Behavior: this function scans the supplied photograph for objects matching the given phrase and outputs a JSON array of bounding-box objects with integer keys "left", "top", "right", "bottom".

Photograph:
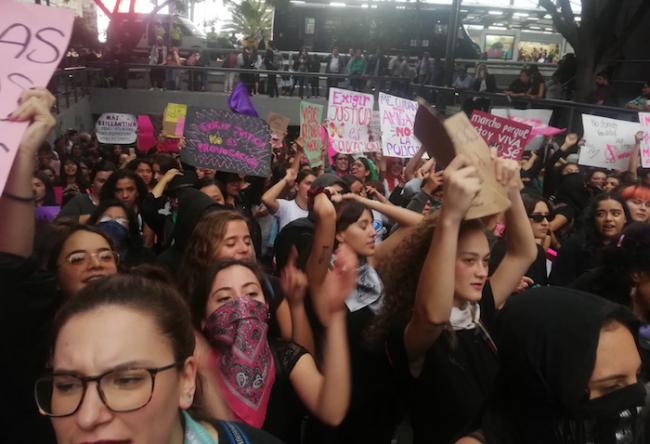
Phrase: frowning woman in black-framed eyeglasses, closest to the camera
[{"left": 34, "top": 275, "right": 279, "bottom": 444}]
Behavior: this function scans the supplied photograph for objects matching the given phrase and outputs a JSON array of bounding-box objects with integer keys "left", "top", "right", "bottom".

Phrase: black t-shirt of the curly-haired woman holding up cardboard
[{"left": 387, "top": 284, "right": 497, "bottom": 444}]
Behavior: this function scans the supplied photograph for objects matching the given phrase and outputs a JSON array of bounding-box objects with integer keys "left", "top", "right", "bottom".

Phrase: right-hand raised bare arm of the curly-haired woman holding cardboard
[{"left": 490, "top": 159, "right": 537, "bottom": 308}]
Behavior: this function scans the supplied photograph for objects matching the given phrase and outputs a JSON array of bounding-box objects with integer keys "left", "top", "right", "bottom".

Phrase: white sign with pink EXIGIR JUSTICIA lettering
[{"left": 327, "top": 88, "right": 380, "bottom": 154}]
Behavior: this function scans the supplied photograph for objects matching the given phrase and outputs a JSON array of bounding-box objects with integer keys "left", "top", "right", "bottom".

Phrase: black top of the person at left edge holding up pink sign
[{"left": 0, "top": 253, "right": 61, "bottom": 444}]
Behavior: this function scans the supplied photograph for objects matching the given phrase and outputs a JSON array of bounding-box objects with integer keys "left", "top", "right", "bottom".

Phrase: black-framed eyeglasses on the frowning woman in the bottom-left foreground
[{"left": 34, "top": 362, "right": 178, "bottom": 418}]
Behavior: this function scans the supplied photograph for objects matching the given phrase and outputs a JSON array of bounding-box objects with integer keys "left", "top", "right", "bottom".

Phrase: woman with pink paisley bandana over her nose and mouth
[{"left": 191, "top": 248, "right": 356, "bottom": 444}]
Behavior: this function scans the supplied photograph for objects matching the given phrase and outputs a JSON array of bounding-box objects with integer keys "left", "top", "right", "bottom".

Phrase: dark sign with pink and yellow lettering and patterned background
[{"left": 181, "top": 106, "right": 271, "bottom": 177}]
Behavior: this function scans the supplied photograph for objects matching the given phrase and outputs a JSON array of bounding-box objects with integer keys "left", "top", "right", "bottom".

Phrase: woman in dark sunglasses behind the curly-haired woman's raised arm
[{"left": 490, "top": 193, "right": 551, "bottom": 291}]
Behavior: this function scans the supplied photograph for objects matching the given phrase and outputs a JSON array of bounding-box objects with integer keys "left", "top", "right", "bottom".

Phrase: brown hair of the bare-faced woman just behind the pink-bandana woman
[{"left": 179, "top": 210, "right": 247, "bottom": 300}]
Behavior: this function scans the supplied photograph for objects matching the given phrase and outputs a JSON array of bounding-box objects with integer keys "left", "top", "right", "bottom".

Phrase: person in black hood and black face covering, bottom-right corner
[{"left": 458, "top": 287, "right": 648, "bottom": 444}]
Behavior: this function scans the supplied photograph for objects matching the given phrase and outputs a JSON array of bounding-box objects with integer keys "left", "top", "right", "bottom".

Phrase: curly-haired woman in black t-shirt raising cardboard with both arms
[{"left": 373, "top": 155, "right": 537, "bottom": 444}]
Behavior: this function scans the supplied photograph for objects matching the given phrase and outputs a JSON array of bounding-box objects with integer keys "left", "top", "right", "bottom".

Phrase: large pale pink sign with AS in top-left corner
[{"left": 0, "top": 0, "right": 74, "bottom": 193}]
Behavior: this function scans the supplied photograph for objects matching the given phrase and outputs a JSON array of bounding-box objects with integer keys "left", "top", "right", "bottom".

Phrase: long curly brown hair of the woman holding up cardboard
[{"left": 366, "top": 215, "right": 485, "bottom": 346}]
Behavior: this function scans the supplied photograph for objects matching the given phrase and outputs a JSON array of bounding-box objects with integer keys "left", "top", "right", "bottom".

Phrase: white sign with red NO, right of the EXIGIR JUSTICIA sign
[{"left": 379, "top": 92, "right": 420, "bottom": 157}]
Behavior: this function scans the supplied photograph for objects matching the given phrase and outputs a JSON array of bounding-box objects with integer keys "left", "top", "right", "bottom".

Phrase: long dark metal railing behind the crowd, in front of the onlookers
[{"left": 49, "top": 63, "right": 638, "bottom": 132}]
